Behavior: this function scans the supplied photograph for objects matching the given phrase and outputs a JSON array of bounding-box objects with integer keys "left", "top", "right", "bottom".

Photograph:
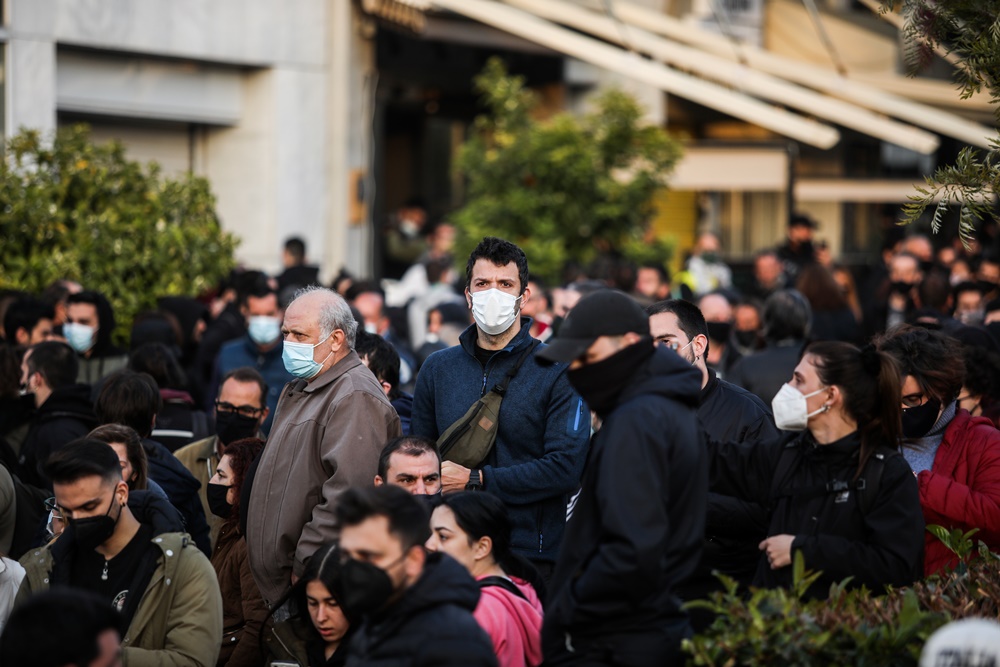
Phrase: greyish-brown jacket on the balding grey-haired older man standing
[{"left": 246, "top": 352, "right": 401, "bottom": 606}]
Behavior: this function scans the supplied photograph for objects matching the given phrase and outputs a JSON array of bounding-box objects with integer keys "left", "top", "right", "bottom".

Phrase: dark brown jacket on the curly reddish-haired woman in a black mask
[{"left": 212, "top": 523, "right": 268, "bottom": 667}]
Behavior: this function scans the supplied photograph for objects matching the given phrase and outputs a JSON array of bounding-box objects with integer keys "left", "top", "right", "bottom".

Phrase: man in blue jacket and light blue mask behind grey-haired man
[{"left": 209, "top": 287, "right": 295, "bottom": 435}]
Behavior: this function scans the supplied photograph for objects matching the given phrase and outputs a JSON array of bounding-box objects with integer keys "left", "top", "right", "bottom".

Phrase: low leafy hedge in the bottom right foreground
[{"left": 684, "top": 526, "right": 1000, "bottom": 667}]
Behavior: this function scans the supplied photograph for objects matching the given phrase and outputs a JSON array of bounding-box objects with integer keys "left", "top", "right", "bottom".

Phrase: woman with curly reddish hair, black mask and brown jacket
[{"left": 206, "top": 438, "right": 267, "bottom": 667}]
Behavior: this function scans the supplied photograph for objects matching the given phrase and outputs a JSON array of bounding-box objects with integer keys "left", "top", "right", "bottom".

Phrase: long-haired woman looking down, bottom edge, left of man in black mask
[{"left": 266, "top": 543, "right": 356, "bottom": 667}]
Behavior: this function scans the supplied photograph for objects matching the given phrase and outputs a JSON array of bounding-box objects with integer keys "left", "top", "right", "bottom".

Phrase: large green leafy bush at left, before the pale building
[{"left": 0, "top": 125, "right": 237, "bottom": 343}]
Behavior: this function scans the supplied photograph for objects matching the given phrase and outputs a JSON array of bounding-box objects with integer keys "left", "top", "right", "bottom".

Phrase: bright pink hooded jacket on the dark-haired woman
[{"left": 472, "top": 577, "right": 542, "bottom": 667}]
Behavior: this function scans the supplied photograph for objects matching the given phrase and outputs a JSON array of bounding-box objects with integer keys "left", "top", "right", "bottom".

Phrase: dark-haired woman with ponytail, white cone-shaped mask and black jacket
[{"left": 709, "top": 341, "right": 924, "bottom": 598}]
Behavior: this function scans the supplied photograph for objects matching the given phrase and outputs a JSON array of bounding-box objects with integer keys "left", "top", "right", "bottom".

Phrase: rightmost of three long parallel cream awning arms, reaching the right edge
[{"left": 615, "top": 0, "right": 997, "bottom": 148}]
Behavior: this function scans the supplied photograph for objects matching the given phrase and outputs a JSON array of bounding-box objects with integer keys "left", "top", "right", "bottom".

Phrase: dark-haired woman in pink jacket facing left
[{"left": 426, "top": 491, "right": 544, "bottom": 667}]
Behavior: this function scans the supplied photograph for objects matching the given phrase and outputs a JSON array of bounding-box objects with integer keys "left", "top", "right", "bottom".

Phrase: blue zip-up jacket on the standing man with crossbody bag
[{"left": 410, "top": 317, "right": 590, "bottom": 562}]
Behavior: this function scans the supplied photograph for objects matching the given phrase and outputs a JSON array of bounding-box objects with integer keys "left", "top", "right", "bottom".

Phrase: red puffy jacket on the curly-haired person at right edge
[{"left": 917, "top": 410, "right": 1000, "bottom": 575}]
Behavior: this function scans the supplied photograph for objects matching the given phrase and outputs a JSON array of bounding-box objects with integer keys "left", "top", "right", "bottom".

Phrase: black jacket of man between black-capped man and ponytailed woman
[{"left": 678, "top": 369, "right": 781, "bottom": 600}]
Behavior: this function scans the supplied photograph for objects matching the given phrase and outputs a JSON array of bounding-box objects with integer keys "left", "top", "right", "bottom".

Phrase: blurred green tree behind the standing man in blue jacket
[{"left": 453, "top": 58, "right": 680, "bottom": 281}]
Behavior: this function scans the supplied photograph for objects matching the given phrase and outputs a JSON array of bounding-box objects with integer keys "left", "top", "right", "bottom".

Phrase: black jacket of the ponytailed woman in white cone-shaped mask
[{"left": 709, "top": 431, "right": 924, "bottom": 597}]
